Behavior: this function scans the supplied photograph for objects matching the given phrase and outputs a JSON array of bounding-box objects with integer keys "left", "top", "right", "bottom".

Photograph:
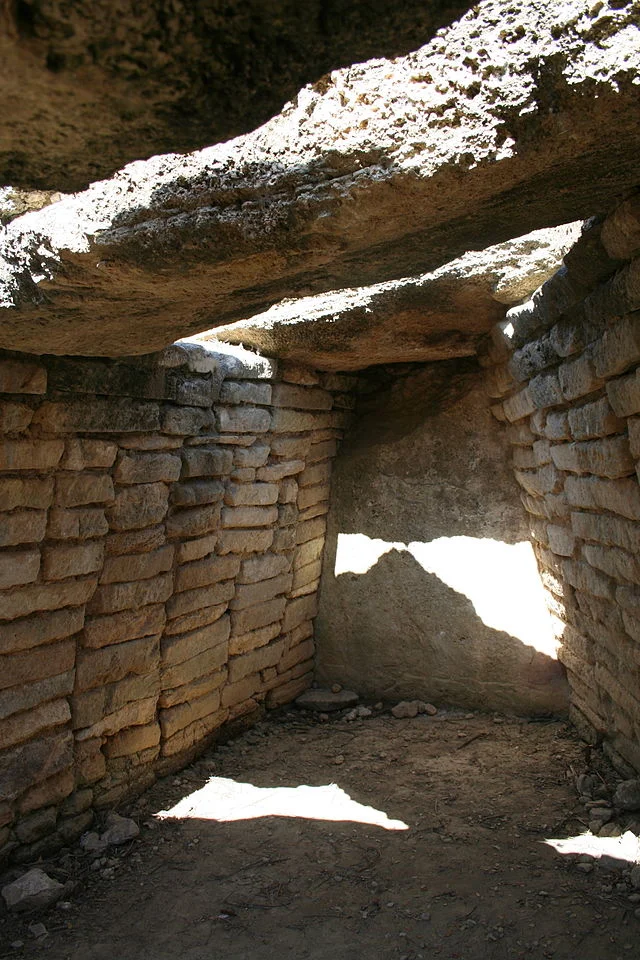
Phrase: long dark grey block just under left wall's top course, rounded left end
[{"left": 34, "top": 396, "right": 160, "bottom": 433}]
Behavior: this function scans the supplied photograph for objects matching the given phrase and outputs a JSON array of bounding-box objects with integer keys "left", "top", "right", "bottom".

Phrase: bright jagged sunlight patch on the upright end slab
[{"left": 335, "top": 533, "right": 559, "bottom": 657}]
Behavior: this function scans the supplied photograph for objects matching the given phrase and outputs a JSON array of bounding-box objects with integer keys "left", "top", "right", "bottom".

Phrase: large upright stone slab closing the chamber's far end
[{"left": 316, "top": 362, "right": 567, "bottom": 714}]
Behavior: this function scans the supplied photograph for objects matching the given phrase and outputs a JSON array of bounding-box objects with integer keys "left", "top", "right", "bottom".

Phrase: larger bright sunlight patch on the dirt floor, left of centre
[{"left": 156, "top": 777, "right": 409, "bottom": 830}]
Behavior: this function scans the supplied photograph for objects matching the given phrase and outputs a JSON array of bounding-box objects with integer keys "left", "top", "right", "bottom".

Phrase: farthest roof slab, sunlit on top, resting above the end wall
[{"left": 212, "top": 222, "right": 580, "bottom": 370}]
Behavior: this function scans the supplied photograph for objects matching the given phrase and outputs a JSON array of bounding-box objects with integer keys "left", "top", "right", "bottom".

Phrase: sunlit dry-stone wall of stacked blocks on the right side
[{"left": 482, "top": 194, "right": 640, "bottom": 773}]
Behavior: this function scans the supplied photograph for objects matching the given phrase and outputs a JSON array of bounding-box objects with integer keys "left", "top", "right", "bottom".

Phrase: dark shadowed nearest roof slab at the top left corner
[{"left": 0, "top": 0, "right": 468, "bottom": 190}]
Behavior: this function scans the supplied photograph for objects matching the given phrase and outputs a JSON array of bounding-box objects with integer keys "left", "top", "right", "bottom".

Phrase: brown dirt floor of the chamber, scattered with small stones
[{"left": 0, "top": 711, "right": 640, "bottom": 960}]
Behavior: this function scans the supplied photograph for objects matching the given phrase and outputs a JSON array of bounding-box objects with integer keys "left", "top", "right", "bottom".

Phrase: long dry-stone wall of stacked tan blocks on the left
[{"left": 0, "top": 343, "right": 352, "bottom": 861}]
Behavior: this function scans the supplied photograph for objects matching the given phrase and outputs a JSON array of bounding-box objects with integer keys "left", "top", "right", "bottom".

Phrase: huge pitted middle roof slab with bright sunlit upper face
[{"left": 0, "top": 0, "right": 640, "bottom": 355}]
